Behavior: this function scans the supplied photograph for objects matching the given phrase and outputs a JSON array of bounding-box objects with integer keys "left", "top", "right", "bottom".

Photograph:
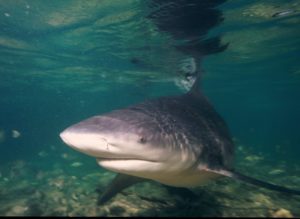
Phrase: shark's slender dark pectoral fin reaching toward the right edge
[{"left": 209, "top": 170, "right": 300, "bottom": 195}]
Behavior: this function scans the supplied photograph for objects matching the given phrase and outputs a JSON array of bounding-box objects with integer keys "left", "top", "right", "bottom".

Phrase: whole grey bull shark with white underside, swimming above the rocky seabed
[{"left": 60, "top": 70, "right": 300, "bottom": 203}]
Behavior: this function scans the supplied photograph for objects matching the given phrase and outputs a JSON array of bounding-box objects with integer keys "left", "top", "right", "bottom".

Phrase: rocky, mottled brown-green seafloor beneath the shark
[{"left": 0, "top": 142, "right": 300, "bottom": 217}]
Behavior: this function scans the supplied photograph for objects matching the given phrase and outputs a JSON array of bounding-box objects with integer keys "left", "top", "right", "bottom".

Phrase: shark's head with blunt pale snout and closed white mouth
[{"left": 60, "top": 109, "right": 195, "bottom": 181}]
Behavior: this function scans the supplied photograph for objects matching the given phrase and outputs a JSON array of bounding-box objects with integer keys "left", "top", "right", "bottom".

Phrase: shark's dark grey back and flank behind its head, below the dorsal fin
[{"left": 108, "top": 93, "right": 234, "bottom": 169}]
